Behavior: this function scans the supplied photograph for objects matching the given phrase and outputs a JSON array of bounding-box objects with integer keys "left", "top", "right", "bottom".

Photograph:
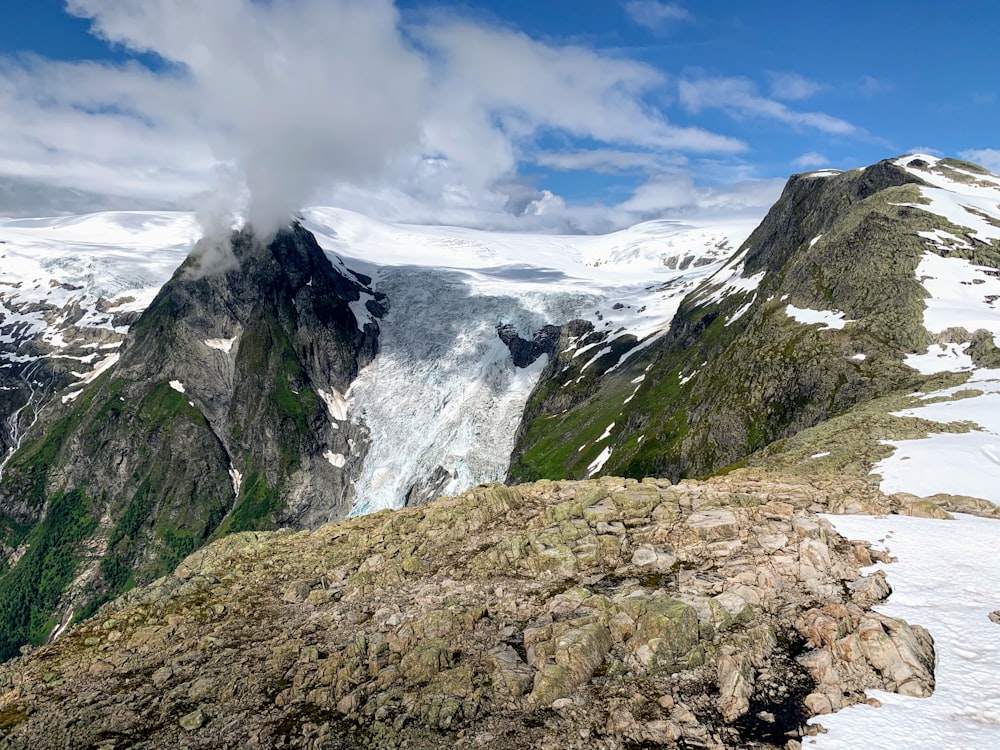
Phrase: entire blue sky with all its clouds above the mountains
[{"left": 0, "top": 0, "right": 1000, "bottom": 231}]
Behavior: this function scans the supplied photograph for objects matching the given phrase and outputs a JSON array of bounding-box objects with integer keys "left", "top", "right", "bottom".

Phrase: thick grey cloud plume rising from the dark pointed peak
[{"left": 68, "top": 0, "right": 426, "bottom": 236}]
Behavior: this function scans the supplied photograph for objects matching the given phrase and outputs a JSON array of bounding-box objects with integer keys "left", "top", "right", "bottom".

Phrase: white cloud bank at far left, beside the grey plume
[{"left": 0, "top": 58, "right": 215, "bottom": 198}]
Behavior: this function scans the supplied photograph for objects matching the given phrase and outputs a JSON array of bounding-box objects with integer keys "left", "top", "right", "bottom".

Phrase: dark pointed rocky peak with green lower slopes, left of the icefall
[{"left": 0, "top": 226, "right": 379, "bottom": 657}]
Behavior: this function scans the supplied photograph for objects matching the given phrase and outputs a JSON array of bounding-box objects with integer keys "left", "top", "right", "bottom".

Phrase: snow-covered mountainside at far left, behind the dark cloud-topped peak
[{"left": 0, "top": 212, "right": 200, "bottom": 464}]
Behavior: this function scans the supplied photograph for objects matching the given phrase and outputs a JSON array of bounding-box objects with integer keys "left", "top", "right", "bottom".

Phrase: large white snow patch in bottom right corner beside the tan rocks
[{"left": 805, "top": 516, "right": 1000, "bottom": 750}]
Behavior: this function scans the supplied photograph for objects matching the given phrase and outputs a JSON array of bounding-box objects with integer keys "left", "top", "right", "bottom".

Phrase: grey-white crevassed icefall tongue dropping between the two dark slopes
[{"left": 347, "top": 267, "right": 598, "bottom": 514}]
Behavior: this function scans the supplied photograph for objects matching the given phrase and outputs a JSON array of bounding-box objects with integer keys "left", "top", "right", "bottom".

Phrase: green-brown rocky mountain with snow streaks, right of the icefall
[{"left": 511, "top": 157, "right": 1000, "bottom": 488}]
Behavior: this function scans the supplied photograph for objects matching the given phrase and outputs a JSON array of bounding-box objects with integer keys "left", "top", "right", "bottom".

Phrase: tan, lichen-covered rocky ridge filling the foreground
[{"left": 0, "top": 471, "right": 944, "bottom": 750}]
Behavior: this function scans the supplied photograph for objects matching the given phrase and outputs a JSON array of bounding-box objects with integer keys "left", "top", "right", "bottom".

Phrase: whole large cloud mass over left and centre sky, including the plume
[{"left": 0, "top": 0, "right": 764, "bottom": 231}]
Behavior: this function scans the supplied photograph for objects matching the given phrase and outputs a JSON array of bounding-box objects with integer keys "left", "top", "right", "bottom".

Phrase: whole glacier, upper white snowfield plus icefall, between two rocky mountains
[{"left": 304, "top": 208, "right": 753, "bottom": 515}]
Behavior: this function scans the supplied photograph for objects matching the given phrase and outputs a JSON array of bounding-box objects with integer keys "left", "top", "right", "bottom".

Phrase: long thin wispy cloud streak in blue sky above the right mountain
[{"left": 678, "top": 76, "right": 864, "bottom": 135}]
